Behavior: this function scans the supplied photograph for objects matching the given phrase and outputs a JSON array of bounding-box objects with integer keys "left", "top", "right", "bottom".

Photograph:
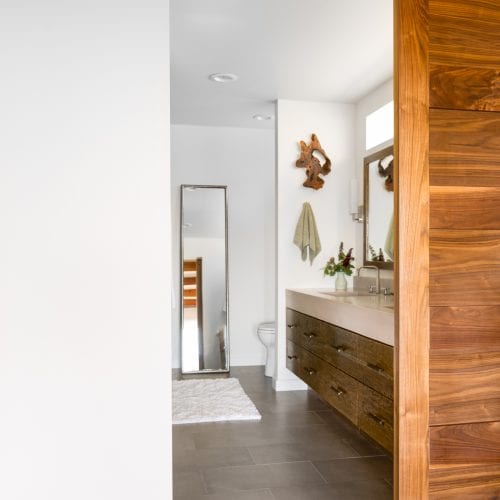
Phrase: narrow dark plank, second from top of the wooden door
[{"left": 430, "top": 64, "right": 500, "bottom": 111}]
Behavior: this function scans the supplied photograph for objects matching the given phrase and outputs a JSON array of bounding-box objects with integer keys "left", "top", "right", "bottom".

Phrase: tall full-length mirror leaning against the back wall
[{"left": 180, "top": 185, "right": 229, "bottom": 374}]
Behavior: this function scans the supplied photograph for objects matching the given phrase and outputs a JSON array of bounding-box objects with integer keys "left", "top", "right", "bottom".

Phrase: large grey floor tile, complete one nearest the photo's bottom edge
[{"left": 203, "top": 462, "right": 325, "bottom": 493}]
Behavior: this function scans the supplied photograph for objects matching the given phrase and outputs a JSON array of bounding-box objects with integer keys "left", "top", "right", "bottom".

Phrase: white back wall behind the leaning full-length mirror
[{"left": 172, "top": 125, "right": 275, "bottom": 367}]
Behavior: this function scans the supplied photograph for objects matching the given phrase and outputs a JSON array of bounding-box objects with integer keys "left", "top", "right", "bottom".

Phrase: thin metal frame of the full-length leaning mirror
[{"left": 179, "top": 184, "right": 230, "bottom": 375}]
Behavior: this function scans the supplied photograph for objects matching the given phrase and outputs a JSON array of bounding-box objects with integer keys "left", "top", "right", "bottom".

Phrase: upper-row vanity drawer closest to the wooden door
[{"left": 357, "top": 335, "right": 394, "bottom": 399}]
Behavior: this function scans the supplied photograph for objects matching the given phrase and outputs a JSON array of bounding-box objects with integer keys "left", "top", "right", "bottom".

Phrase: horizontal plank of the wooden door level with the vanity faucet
[{"left": 429, "top": 229, "right": 500, "bottom": 306}]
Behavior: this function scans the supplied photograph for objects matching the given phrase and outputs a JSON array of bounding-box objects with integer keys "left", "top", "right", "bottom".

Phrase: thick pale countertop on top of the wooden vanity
[{"left": 286, "top": 288, "right": 394, "bottom": 346}]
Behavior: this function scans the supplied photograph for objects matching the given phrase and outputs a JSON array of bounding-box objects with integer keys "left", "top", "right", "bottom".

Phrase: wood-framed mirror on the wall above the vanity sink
[{"left": 364, "top": 146, "right": 394, "bottom": 269}]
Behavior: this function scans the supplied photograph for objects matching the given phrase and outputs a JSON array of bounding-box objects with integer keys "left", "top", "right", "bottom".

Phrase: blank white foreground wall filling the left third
[{"left": 0, "top": 4, "right": 171, "bottom": 500}]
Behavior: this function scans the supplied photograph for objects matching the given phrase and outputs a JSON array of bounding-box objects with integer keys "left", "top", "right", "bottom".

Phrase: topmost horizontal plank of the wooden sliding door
[{"left": 429, "top": 0, "right": 500, "bottom": 69}]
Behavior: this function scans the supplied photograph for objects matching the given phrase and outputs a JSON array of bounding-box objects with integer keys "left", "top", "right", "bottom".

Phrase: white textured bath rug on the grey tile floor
[{"left": 172, "top": 378, "right": 261, "bottom": 424}]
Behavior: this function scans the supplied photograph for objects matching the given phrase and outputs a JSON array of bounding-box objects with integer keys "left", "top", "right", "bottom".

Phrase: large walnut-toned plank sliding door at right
[{"left": 395, "top": 0, "right": 500, "bottom": 500}]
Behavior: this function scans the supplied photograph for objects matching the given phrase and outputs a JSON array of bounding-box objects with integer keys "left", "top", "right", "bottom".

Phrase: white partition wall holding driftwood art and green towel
[{"left": 274, "top": 100, "right": 362, "bottom": 390}]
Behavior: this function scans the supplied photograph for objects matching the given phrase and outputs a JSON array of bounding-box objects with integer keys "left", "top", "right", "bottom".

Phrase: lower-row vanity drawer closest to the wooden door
[{"left": 358, "top": 386, "right": 394, "bottom": 453}]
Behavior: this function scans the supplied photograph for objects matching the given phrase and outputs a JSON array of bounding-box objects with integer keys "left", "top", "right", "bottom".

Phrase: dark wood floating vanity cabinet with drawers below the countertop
[{"left": 286, "top": 309, "right": 394, "bottom": 453}]
